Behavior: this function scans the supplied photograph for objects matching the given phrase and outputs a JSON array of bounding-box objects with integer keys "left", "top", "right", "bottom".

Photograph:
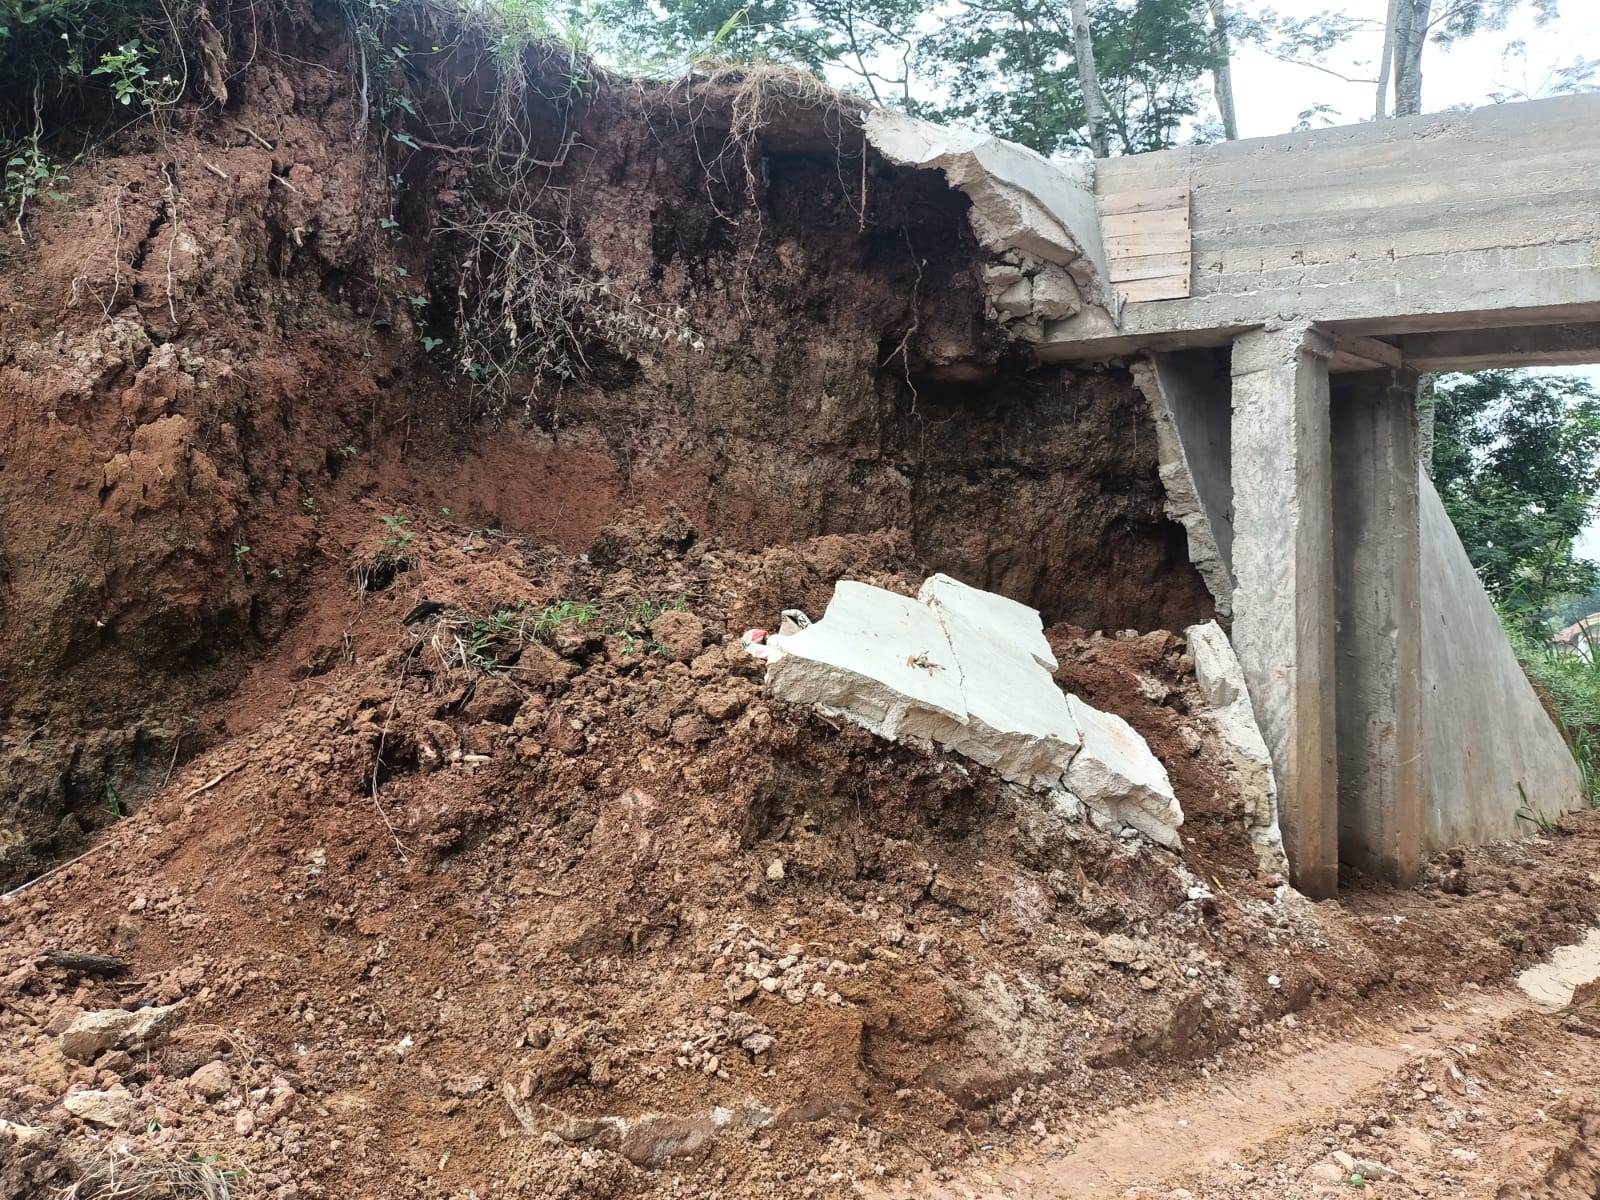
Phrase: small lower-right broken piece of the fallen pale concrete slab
[{"left": 1067, "top": 696, "right": 1184, "bottom": 850}]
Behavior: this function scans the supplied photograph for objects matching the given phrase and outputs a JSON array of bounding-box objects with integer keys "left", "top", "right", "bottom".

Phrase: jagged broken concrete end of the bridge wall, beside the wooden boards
[{"left": 864, "top": 109, "right": 1122, "bottom": 331}]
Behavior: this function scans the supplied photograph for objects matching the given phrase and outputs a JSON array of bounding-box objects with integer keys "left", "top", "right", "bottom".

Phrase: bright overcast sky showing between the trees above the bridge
[{"left": 1234, "top": 0, "right": 1600, "bottom": 560}]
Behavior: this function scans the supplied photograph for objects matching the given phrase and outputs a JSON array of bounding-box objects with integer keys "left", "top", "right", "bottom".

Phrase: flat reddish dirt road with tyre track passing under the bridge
[{"left": 885, "top": 936, "right": 1600, "bottom": 1200}]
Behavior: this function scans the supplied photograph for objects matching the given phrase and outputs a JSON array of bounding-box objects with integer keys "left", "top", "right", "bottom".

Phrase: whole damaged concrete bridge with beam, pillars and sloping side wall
[{"left": 867, "top": 96, "right": 1600, "bottom": 896}]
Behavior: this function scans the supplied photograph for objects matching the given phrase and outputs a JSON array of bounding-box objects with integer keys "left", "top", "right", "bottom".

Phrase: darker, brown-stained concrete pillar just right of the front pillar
[{"left": 1331, "top": 371, "right": 1424, "bottom": 885}]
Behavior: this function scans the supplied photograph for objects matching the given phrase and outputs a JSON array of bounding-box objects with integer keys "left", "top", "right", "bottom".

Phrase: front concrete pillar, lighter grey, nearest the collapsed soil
[{"left": 1232, "top": 326, "right": 1339, "bottom": 898}]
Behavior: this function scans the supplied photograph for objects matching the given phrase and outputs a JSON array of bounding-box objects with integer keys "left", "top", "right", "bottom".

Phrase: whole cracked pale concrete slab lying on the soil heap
[{"left": 766, "top": 574, "right": 1184, "bottom": 850}]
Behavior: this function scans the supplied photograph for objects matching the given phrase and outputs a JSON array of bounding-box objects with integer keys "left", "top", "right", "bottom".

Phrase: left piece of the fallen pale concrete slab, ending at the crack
[{"left": 766, "top": 579, "right": 966, "bottom": 741}]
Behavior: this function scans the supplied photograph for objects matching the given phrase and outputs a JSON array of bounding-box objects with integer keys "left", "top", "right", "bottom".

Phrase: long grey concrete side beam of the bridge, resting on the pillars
[{"left": 1040, "top": 96, "right": 1600, "bottom": 361}]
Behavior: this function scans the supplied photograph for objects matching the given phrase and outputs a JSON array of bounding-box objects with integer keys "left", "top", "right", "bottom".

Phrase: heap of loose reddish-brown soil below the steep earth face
[{"left": 0, "top": 506, "right": 1586, "bottom": 1197}]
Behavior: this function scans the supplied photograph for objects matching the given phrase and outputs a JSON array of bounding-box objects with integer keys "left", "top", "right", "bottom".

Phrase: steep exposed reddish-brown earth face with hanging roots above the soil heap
[{"left": 0, "top": 5, "right": 1210, "bottom": 882}]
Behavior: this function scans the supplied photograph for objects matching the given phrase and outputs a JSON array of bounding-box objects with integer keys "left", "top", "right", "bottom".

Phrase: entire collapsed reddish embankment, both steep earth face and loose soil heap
[{"left": 9, "top": 5, "right": 1589, "bottom": 1200}]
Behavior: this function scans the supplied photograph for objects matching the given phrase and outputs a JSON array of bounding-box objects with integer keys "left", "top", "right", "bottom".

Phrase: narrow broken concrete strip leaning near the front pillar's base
[{"left": 1186, "top": 621, "right": 1288, "bottom": 870}]
